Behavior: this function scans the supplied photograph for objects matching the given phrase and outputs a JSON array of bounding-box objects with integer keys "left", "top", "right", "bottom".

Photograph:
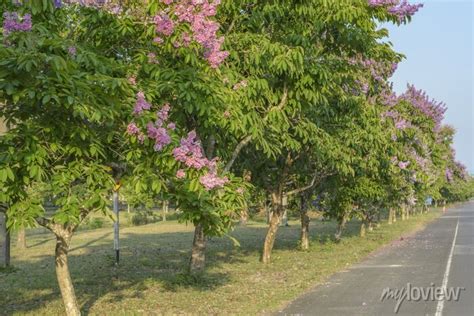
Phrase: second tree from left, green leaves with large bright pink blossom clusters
[{"left": 119, "top": 1, "right": 252, "bottom": 272}]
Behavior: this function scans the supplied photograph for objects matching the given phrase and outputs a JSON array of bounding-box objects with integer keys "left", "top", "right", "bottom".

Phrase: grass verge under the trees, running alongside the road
[{"left": 0, "top": 211, "right": 440, "bottom": 316}]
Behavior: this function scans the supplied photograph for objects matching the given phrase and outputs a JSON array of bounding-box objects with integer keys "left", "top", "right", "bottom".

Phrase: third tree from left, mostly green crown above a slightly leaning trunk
[{"left": 217, "top": 1, "right": 412, "bottom": 262}]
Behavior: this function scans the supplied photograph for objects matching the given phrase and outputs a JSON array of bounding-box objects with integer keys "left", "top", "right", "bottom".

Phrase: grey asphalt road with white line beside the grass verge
[{"left": 277, "top": 201, "right": 474, "bottom": 316}]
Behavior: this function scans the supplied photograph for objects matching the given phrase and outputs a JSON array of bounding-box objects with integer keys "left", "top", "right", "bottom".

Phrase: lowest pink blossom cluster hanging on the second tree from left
[{"left": 173, "top": 131, "right": 229, "bottom": 190}]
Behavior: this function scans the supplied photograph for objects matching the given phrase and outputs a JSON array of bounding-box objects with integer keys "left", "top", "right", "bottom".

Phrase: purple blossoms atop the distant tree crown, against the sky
[{"left": 400, "top": 85, "right": 447, "bottom": 130}]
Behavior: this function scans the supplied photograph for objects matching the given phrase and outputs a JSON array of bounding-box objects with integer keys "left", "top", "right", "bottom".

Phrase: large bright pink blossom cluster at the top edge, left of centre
[{"left": 154, "top": 0, "right": 229, "bottom": 68}]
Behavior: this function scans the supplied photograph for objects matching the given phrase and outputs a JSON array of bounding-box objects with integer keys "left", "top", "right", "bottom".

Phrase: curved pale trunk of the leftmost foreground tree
[{"left": 55, "top": 231, "right": 81, "bottom": 316}]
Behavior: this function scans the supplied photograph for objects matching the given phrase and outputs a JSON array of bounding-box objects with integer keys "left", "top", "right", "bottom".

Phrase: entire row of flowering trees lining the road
[{"left": 0, "top": 0, "right": 472, "bottom": 315}]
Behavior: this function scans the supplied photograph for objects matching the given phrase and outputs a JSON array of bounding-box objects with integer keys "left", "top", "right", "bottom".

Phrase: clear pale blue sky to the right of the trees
[{"left": 384, "top": 0, "right": 474, "bottom": 174}]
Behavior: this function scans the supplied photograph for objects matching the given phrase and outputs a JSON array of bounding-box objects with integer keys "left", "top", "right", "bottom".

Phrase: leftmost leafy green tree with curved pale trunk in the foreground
[{"left": 0, "top": 1, "right": 136, "bottom": 315}]
